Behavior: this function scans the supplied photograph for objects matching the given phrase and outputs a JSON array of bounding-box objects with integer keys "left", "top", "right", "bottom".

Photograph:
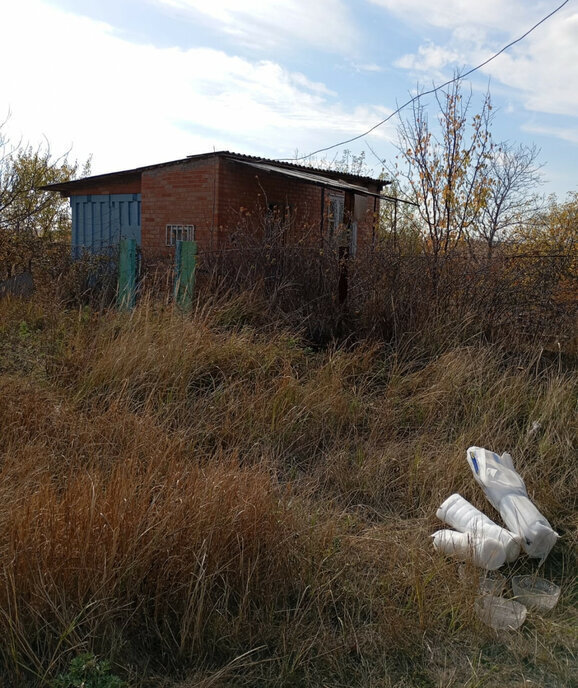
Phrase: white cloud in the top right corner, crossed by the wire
[{"left": 371, "top": 0, "right": 578, "bottom": 128}]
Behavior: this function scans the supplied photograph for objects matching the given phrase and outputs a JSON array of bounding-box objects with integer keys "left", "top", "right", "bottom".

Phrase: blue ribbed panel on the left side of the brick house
[{"left": 70, "top": 194, "right": 141, "bottom": 256}]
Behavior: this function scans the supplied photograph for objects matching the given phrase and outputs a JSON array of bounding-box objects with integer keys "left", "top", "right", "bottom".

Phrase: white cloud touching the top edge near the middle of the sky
[{"left": 149, "top": 0, "right": 359, "bottom": 55}]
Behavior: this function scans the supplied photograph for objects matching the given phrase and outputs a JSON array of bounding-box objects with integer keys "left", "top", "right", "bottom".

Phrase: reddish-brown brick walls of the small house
[{"left": 64, "top": 156, "right": 379, "bottom": 259}]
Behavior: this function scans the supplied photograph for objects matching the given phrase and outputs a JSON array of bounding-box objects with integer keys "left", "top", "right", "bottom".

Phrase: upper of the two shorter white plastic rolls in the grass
[{"left": 436, "top": 493, "right": 522, "bottom": 562}]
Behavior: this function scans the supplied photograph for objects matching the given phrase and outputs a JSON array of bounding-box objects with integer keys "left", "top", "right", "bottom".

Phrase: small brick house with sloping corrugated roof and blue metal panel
[{"left": 43, "top": 151, "right": 390, "bottom": 258}]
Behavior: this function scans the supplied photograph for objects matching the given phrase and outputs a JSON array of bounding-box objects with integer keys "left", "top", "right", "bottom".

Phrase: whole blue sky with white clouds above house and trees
[{"left": 0, "top": 0, "right": 578, "bottom": 199}]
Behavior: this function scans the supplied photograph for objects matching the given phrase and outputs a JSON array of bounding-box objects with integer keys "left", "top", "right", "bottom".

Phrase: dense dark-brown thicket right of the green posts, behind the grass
[{"left": 199, "top": 240, "right": 578, "bottom": 356}]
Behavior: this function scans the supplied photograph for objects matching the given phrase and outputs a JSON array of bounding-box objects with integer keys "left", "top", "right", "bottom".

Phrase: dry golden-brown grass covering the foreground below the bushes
[{"left": 0, "top": 250, "right": 578, "bottom": 688}]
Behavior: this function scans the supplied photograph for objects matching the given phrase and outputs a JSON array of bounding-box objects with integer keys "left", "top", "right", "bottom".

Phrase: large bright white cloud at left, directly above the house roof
[{"left": 0, "top": 0, "right": 390, "bottom": 173}]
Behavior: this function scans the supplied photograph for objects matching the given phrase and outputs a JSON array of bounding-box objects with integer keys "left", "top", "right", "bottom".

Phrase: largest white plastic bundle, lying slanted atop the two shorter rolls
[{"left": 466, "top": 447, "right": 559, "bottom": 561}]
